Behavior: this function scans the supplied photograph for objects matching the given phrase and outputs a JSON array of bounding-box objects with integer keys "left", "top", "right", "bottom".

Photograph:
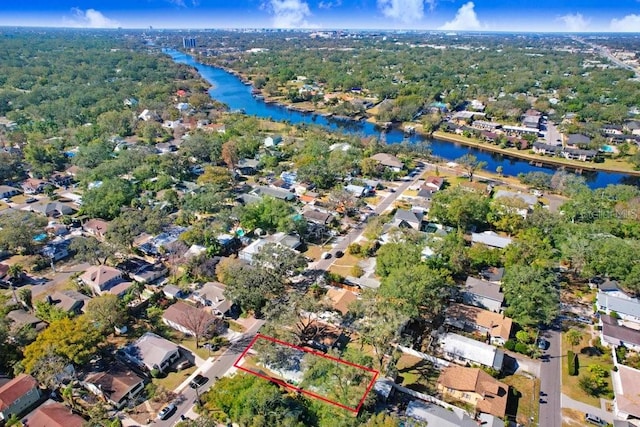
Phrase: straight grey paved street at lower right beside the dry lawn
[{"left": 538, "top": 330, "right": 564, "bottom": 427}]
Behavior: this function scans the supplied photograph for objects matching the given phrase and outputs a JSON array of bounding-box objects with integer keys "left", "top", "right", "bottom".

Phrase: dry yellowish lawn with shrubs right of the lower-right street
[{"left": 561, "top": 330, "right": 613, "bottom": 407}]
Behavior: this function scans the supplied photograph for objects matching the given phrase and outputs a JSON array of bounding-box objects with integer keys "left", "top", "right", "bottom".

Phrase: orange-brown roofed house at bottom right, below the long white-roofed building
[{"left": 437, "top": 366, "right": 509, "bottom": 418}]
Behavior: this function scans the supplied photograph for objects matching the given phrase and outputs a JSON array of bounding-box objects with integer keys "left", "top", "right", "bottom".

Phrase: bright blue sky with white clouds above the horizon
[{"left": 0, "top": 0, "right": 640, "bottom": 32}]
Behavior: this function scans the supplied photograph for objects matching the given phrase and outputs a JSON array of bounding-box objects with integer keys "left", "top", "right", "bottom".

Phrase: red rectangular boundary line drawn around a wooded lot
[{"left": 233, "top": 334, "right": 380, "bottom": 414}]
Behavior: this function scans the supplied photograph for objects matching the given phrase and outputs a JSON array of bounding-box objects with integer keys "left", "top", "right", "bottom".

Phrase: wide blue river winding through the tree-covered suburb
[{"left": 163, "top": 49, "right": 640, "bottom": 188}]
